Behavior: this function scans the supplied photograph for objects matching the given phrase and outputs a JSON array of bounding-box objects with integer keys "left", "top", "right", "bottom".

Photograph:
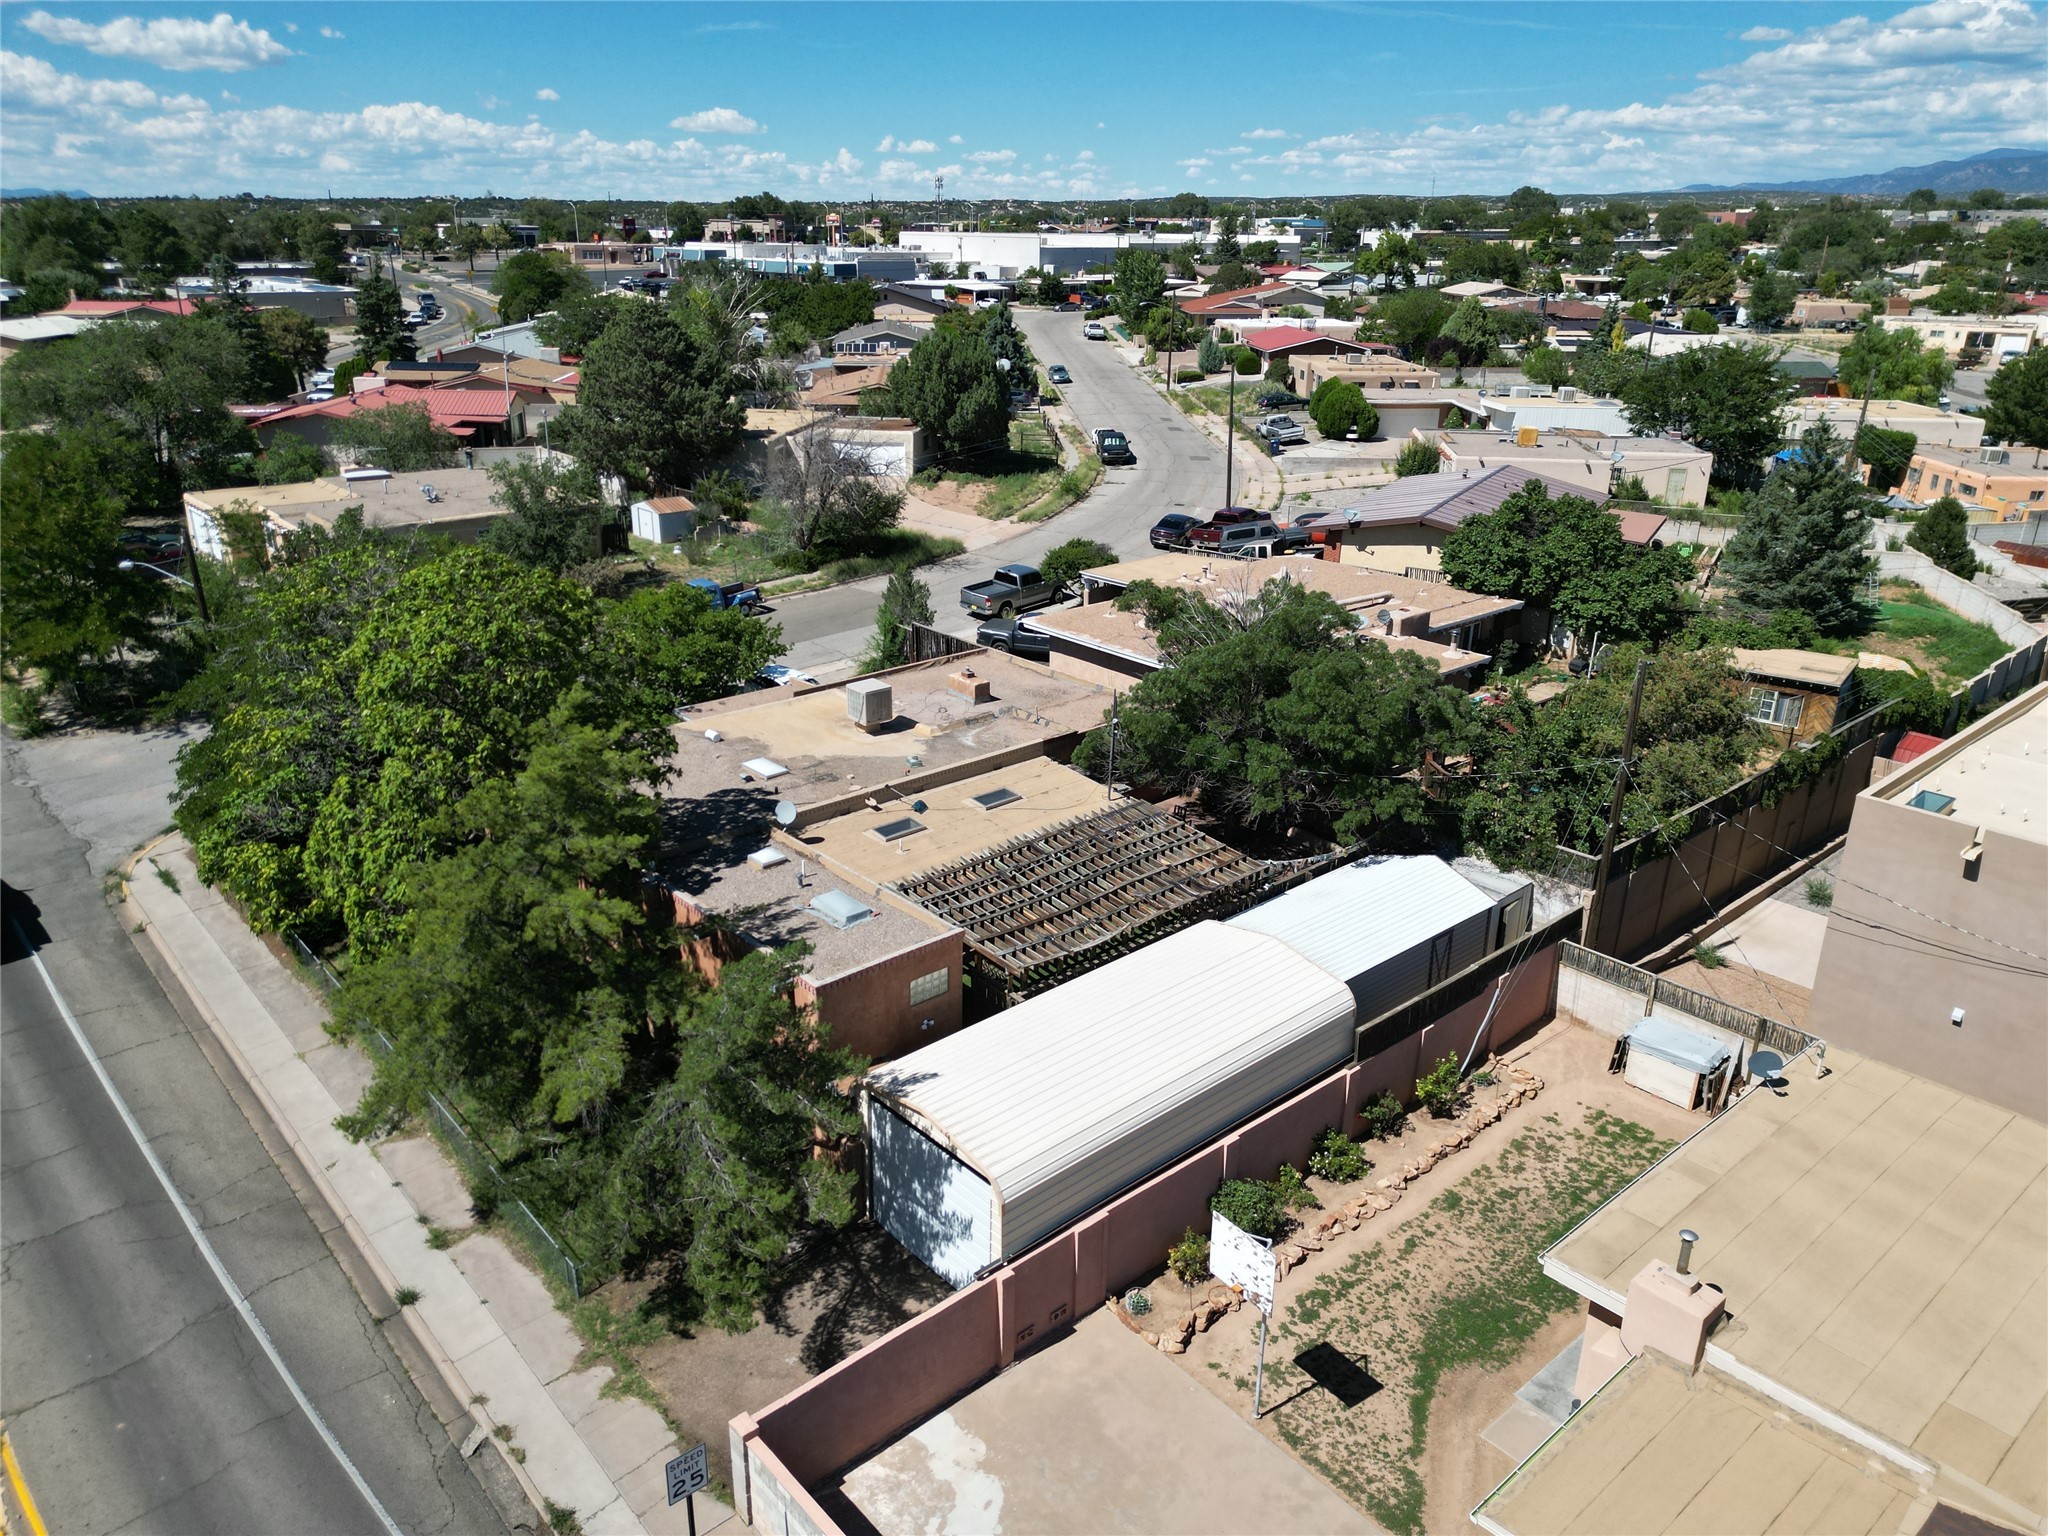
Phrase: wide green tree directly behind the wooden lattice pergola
[{"left": 1075, "top": 580, "right": 1468, "bottom": 842}]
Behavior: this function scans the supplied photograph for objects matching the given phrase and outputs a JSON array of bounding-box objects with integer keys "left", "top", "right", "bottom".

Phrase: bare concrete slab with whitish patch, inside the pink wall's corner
[{"left": 838, "top": 1309, "right": 1374, "bottom": 1536}]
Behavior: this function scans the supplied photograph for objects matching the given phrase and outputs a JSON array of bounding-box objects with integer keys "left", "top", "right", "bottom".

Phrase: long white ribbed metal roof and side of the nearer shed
[{"left": 868, "top": 922, "right": 1354, "bottom": 1253}]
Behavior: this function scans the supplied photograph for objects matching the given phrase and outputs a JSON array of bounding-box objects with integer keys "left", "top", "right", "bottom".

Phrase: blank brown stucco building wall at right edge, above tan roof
[{"left": 1808, "top": 795, "right": 2048, "bottom": 1120}]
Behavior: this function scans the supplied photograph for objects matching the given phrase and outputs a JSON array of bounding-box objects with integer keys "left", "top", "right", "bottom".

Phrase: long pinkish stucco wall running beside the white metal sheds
[{"left": 731, "top": 944, "right": 1559, "bottom": 1536}]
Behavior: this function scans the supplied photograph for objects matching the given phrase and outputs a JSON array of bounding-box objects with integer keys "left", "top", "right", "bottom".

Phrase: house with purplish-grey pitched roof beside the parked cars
[{"left": 1292, "top": 465, "right": 1665, "bottom": 580}]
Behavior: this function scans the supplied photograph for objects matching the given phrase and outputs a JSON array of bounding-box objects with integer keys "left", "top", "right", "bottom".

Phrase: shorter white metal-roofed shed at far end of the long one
[{"left": 1229, "top": 858, "right": 1532, "bottom": 1024}]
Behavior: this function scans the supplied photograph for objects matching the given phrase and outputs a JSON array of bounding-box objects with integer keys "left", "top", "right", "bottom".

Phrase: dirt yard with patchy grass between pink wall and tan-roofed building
[{"left": 1153, "top": 1024, "right": 1702, "bottom": 1532}]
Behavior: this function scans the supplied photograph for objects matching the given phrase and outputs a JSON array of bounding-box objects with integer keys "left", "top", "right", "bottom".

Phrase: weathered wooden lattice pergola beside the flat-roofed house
[{"left": 895, "top": 801, "right": 1272, "bottom": 997}]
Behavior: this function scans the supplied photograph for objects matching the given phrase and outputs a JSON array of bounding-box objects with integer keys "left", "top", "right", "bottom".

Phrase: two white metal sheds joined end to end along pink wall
[{"left": 864, "top": 858, "right": 1526, "bottom": 1286}]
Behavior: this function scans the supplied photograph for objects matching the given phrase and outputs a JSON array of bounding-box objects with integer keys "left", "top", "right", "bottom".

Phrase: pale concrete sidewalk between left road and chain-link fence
[{"left": 127, "top": 838, "right": 731, "bottom": 1536}]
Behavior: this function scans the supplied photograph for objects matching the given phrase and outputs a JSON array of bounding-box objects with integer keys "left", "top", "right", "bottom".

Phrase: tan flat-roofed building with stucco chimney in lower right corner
[{"left": 1473, "top": 1056, "right": 2048, "bottom": 1536}]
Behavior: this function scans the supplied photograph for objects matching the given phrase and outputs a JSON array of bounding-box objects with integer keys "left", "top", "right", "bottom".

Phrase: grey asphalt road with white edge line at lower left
[{"left": 0, "top": 757, "right": 516, "bottom": 1536}]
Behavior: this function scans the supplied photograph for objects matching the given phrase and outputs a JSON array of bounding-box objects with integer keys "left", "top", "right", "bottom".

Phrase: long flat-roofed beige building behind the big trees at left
[{"left": 184, "top": 469, "right": 520, "bottom": 559}]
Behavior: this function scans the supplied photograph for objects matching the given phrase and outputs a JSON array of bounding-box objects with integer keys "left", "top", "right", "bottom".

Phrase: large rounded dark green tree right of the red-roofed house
[{"left": 555, "top": 303, "right": 745, "bottom": 492}]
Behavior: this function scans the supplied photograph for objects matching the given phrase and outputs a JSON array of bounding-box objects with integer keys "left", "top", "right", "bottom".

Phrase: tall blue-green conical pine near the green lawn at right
[{"left": 1720, "top": 422, "right": 1872, "bottom": 635}]
